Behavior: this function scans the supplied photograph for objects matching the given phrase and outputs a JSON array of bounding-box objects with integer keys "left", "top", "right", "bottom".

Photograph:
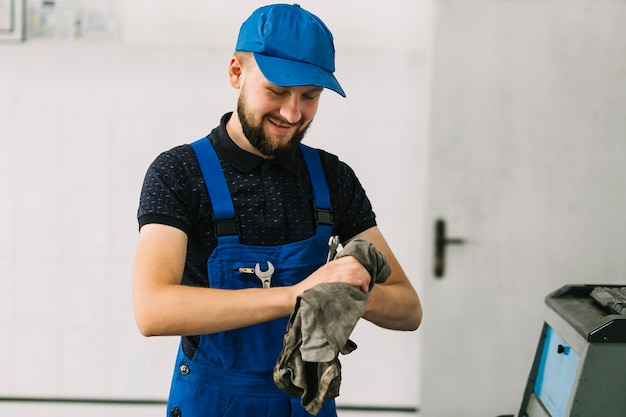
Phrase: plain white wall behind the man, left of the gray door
[{"left": 0, "top": 0, "right": 431, "bottom": 416}]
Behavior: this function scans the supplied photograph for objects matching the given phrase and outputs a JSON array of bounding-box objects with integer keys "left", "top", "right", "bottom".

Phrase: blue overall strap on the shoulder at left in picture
[{"left": 190, "top": 137, "right": 239, "bottom": 243}]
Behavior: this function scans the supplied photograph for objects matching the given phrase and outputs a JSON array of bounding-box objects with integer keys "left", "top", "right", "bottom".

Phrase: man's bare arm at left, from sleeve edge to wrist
[{"left": 133, "top": 224, "right": 297, "bottom": 336}]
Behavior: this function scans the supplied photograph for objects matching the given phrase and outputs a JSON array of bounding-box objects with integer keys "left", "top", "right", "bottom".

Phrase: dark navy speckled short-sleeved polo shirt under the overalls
[{"left": 137, "top": 113, "right": 376, "bottom": 353}]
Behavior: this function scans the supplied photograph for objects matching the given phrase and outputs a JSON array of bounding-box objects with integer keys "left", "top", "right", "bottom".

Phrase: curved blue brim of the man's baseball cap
[{"left": 254, "top": 52, "right": 346, "bottom": 97}]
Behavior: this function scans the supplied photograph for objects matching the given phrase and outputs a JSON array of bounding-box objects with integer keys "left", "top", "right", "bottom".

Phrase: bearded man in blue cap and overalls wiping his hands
[{"left": 133, "top": 4, "right": 422, "bottom": 417}]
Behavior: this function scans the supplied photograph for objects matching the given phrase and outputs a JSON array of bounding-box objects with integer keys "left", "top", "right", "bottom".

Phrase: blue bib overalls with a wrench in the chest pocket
[{"left": 167, "top": 138, "right": 337, "bottom": 417}]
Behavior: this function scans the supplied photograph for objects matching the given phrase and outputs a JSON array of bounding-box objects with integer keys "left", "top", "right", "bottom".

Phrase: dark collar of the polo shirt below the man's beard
[{"left": 209, "top": 112, "right": 297, "bottom": 174}]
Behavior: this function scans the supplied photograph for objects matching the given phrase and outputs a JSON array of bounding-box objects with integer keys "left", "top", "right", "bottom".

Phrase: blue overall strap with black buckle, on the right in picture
[{"left": 300, "top": 144, "right": 333, "bottom": 234}]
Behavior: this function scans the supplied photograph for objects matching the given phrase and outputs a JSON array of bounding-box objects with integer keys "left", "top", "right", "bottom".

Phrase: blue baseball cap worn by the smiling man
[{"left": 235, "top": 4, "right": 346, "bottom": 97}]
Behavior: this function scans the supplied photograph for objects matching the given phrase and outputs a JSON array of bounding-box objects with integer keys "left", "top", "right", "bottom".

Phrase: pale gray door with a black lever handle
[{"left": 420, "top": 0, "right": 626, "bottom": 417}]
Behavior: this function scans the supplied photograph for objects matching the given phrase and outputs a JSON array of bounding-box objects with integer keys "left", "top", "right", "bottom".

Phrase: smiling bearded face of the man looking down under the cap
[{"left": 229, "top": 57, "right": 323, "bottom": 158}]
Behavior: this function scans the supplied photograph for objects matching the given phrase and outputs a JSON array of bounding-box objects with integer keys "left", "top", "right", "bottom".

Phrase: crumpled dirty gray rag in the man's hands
[{"left": 274, "top": 239, "right": 391, "bottom": 415}]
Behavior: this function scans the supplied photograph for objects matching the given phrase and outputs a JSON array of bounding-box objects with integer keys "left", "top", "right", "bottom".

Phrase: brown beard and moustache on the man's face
[{"left": 237, "top": 94, "right": 311, "bottom": 158}]
